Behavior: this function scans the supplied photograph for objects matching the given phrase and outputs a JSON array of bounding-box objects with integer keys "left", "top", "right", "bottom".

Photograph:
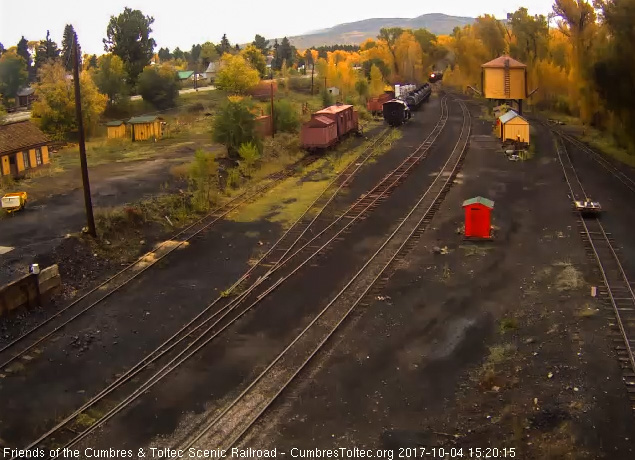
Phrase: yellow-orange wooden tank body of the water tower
[{"left": 481, "top": 56, "right": 527, "bottom": 100}]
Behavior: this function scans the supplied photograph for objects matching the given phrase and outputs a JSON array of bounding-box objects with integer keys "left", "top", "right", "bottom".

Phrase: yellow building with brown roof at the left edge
[{"left": 0, "top": 120, "right": 50, "bottom": 178}]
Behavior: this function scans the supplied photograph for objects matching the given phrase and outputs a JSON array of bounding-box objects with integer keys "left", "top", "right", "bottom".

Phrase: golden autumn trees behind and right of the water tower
[{"left": 443, "top": 0, "right": 635, "bottom": 151}]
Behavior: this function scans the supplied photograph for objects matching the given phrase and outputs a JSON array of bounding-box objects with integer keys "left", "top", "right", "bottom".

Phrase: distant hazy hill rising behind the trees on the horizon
[{"left": 289, "top": 13, "right": 474, "bottom": 49}]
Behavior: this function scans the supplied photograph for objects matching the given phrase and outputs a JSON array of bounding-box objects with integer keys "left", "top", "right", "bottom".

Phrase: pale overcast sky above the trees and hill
[{"left": 0, "top": 0, "right": 553, "bottom": 55}]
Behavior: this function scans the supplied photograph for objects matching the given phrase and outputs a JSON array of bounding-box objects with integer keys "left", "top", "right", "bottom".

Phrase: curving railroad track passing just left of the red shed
[{"left": 175, "top": 101, "right": 471, "bottom": 449}]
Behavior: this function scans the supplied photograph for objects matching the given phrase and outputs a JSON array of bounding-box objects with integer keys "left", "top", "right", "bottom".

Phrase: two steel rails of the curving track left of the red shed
[{"left": 182, "top": 101, "right": 471, "bottom": 449}]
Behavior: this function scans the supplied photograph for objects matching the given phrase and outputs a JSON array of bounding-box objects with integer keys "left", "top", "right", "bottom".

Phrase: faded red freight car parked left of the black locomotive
[{"left": 300, "top": 105, "right": 359, "bottom": 150}]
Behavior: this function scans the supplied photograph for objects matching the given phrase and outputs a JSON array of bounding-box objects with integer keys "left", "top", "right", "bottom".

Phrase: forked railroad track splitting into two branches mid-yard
[{"left": 18, "top": 99, "right": 448, "bottom": 456}]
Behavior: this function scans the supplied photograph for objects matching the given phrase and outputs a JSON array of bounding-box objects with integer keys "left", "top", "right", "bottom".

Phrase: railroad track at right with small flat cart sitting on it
[{"left": 555, "top": 131, "right": 635, "bottom": 411}]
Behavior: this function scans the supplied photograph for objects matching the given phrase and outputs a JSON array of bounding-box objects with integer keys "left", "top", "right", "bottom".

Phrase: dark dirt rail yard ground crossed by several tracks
[{"left": 0, "top": 85, "right": 635, "bottom": 459}]
